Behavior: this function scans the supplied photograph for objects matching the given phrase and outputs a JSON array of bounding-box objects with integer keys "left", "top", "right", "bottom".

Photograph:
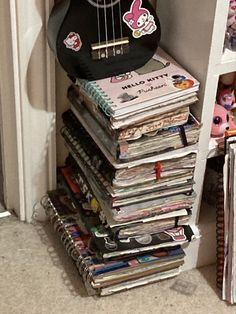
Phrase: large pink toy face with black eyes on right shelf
[{"left": 211, "top": 104, "right": 229, "bottom": 137}]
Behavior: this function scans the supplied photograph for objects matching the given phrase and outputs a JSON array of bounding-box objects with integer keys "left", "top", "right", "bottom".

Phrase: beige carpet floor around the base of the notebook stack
[{"left": 0, "top": 216, "right": 236, "bottom": 314}]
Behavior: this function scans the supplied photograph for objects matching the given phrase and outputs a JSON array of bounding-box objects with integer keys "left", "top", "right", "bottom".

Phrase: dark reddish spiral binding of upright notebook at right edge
[{"left": 216, "top": 158, "right": 224, "bottom": 289}]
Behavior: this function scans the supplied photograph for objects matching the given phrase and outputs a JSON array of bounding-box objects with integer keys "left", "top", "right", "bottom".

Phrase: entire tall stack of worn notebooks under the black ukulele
[{"left": 43, "top": 49, "right": 200, "bottom": 295}]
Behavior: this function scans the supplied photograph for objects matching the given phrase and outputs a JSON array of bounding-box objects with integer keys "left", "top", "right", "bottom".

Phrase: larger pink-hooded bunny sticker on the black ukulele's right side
[{"left": 123, "top": 0, "right": 157, "bottom": 38}]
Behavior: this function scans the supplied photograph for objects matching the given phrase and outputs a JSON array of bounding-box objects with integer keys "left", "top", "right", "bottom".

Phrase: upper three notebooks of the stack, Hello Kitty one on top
[{"left": 68, "top": 49, "right": 200, "bottom": 164}]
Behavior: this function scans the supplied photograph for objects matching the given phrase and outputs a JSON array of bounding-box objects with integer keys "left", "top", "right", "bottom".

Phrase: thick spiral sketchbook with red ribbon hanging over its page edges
[{"left": 62, "top": 128, "right": 196, "bottom": 199}]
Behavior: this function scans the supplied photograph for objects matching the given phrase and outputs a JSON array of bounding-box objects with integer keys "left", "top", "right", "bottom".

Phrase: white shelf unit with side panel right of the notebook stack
[{"left": 156, "top": 0, "right": 236, "bottom": 269}]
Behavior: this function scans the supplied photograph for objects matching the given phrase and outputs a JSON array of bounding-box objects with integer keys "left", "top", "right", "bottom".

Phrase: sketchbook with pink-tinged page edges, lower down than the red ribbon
[{"left": 65, "top": 147, "right": 195, "bottom": 228}]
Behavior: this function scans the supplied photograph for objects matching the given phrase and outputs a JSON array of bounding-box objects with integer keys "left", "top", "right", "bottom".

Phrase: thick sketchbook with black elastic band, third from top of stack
[{"left": 62, "top": 106, "right": 201, "bottom": 165}]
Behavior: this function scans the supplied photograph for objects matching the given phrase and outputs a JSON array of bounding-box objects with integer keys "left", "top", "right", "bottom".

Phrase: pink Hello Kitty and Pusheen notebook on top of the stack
[{"left": 76, "top": 48, "right": 199, "bottom": 116}]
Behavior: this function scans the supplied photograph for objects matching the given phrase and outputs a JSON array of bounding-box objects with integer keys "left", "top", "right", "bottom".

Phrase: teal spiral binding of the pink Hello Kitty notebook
[{"left": 76, "top": 79, "right": 113, "bottom": 117}]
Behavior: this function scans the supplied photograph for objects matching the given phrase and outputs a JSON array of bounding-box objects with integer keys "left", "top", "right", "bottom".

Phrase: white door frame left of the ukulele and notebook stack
[{"left": 0, "top": 0, "right": 56, "bottom": 222}]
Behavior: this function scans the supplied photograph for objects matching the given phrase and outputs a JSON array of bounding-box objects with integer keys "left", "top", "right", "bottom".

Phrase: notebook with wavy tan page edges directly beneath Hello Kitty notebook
[{"left": 67, "top": 85, "right": 193, "bottom": 135}]
